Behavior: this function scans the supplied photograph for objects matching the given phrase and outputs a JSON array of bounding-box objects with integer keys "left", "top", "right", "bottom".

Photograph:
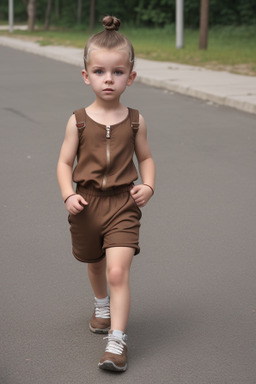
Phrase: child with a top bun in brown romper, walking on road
[{"left": 57, "top": 16, "right": 155, "bottom": 372}]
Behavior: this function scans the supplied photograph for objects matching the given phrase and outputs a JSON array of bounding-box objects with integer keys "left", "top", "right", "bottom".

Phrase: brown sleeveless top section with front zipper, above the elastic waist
[{"left": 73, "top": 108, "right": 139, "bottom": 190}]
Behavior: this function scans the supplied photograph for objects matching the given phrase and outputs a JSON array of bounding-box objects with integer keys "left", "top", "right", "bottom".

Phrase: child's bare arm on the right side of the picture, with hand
[{"left": 131, "top": 115, "right": 155, "bottom": 207}]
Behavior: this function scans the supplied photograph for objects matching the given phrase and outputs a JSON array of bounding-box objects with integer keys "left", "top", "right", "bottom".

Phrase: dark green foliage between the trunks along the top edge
[{"left": 0, "top": 0, "right": 256, "bottom": 28}]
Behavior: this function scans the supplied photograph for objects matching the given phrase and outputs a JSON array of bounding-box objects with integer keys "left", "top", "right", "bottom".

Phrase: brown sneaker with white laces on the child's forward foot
[{"left": 98, "top": 331, "right": 127, "bottom": 372}]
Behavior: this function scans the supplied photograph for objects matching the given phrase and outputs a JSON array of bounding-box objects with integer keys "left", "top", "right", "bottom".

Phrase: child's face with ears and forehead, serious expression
[{"left": 82, "top": 48, "right": 136, "bottom": 100}]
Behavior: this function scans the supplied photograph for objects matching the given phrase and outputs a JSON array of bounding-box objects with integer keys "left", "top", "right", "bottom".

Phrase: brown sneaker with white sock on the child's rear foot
[{"left": 89, "top": 302, "right": 110, "bottom": 333}]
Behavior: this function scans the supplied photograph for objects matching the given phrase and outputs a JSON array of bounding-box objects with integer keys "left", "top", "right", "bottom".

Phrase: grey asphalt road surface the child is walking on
[{"left": 0, "top": 47, "right": 256, "bottom": 384}]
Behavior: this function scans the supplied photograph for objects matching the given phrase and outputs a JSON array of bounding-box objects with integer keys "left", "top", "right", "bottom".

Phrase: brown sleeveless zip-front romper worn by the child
[{"left": 69, "top": 108, "right": 141, "bottom": 263}]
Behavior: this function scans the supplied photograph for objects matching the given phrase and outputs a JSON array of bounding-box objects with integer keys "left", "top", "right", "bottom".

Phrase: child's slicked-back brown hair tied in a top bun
[{"left": 84, "top": 16, "right": 134, "bottom": 70}]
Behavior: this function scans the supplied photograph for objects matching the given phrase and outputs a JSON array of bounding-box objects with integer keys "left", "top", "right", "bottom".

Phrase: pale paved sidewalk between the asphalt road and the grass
[{"left": 0, "top": 36, "right": 256, "bottom": 113}]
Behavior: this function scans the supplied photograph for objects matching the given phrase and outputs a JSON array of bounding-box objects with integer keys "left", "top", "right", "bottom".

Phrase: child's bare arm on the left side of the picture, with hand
[{"left": 57, "top": 115, "right": 87, "bottom": 215}]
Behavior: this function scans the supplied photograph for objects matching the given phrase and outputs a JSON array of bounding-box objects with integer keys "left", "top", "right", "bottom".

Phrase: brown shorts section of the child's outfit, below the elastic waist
[{"left": 68, "top": 185, "right": 141, "bottom": 263}]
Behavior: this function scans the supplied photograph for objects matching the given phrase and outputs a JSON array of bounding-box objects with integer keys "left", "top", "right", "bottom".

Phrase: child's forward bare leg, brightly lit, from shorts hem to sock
[{"left": 106, "top": 247, "right": 134, "bottom": 332}]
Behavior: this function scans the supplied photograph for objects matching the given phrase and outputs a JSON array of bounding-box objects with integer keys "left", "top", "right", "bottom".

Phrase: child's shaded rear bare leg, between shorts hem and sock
[{"left": 88, "top": 258, "right": 108, "bottom": 299}]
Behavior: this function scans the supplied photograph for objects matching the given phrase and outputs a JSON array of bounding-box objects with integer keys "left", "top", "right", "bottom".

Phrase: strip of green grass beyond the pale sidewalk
[{"left": 0, "top": 25, "right": 256, "bottom": 76}]
